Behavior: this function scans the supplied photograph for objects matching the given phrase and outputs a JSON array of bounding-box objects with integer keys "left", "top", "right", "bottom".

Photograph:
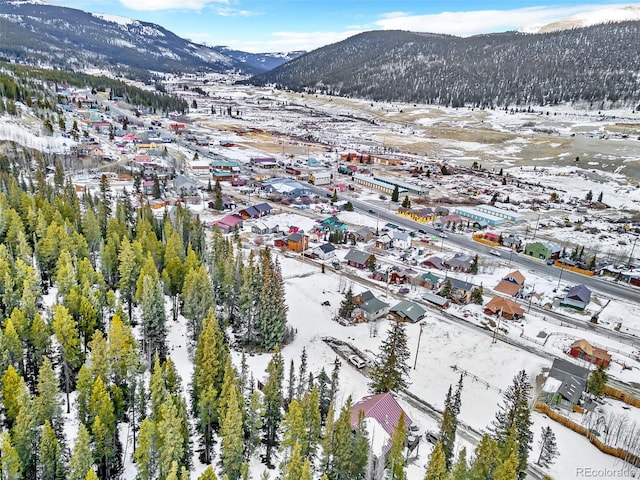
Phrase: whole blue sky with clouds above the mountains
[{"left": 47, "top": 0, "right": 628, "bottom": 52}]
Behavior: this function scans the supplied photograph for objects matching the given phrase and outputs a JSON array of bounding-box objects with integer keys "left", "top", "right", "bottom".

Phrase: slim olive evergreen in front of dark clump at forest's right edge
[{"left": 262, "top": 349, "right": 284, "bottom": 465}]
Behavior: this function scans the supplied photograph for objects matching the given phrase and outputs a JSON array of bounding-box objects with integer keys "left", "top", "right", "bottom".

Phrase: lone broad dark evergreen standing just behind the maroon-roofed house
[{"left": 369, "top": 322, "right": 411, "bottom": 393}]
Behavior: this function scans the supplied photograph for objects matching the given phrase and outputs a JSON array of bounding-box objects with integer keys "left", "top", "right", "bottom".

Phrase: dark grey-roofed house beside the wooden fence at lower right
[{"left": 542, "top": 358, "right": 589, "bottom": 410}]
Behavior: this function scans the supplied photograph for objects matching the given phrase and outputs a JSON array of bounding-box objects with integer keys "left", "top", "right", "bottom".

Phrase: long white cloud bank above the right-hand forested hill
[{"left": 375, "top": 4, "right": 623, "bottom": 37}]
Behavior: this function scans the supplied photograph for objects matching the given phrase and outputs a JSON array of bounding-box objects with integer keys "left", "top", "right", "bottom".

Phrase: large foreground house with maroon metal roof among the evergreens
[{"left": 351, "top": 392, "right": 413, "bottom": 463}]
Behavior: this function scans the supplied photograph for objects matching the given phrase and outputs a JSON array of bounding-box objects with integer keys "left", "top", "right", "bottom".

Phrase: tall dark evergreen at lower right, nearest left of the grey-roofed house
[{"left": 491, "top": 370, "right": 533, "bottom": 477}]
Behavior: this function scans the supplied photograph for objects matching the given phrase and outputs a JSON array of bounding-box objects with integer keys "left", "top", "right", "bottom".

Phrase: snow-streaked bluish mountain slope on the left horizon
[{"left": 0, "top": 0, "right": 296, "bottom": 74}]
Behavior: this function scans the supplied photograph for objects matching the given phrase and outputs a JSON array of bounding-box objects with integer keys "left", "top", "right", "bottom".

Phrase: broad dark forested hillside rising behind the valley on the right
[{"left": 248, "top": 22, "right": 640, "bottom": 108}]
